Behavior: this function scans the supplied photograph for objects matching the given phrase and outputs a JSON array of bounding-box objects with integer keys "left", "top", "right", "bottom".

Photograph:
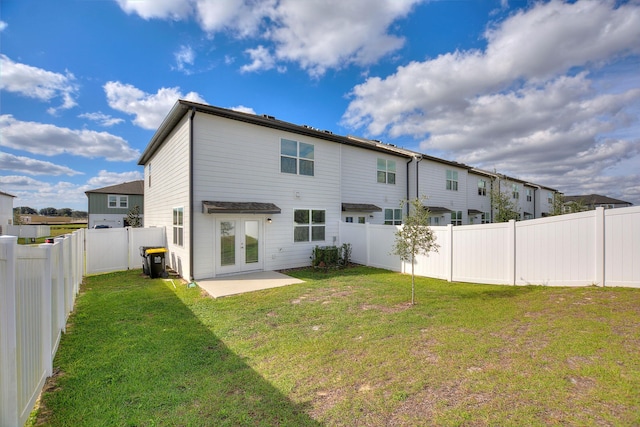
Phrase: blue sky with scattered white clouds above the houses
[{"left": 0, "top": 0, "right": 640, "bottom": 211}]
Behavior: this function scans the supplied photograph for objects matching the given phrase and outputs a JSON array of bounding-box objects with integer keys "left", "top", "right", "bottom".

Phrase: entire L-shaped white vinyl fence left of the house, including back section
[{"left": 0, "top": 228, "right": 165, "bottom": 427}]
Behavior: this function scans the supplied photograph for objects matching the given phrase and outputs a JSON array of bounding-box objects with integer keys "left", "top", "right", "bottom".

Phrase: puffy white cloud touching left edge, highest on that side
[{"left": 0, "top": 54, "right": 77, "bottom": 114}]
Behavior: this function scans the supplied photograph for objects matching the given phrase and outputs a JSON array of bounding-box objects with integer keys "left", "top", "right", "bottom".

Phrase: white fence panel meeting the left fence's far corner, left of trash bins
[{"left": 85, "top": 228, "right": 129, "bottom": 274}]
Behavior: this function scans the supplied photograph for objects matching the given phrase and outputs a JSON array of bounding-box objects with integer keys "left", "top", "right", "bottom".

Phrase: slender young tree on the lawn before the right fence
[{"left": 393, "top": 196, "right": 439, "bottom": 305}]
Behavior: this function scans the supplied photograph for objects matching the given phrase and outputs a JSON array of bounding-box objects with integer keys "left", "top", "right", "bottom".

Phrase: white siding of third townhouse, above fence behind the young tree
[{"left": 416, "top": 159, "right": 468, "bottom": 225}]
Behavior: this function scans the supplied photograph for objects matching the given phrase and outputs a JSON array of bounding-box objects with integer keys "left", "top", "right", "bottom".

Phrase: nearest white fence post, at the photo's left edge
[{"left": 0, "top": 236, "right": 19, "bottom": 427}]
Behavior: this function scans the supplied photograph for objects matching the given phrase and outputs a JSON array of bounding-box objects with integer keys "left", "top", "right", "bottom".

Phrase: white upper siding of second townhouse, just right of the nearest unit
[{"left": 341, "top": 145, "right": 409, "bottom": 224}]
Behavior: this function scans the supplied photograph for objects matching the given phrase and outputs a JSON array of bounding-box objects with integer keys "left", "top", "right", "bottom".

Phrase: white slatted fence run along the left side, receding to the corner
[{"left": 0, "top": 230, "right": 84, "bottom": 426}]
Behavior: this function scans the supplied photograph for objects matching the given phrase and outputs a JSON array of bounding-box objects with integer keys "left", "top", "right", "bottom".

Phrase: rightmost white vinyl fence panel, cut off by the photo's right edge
[{"left": 604, "top": 206, "right": 640, "bottom": 288}]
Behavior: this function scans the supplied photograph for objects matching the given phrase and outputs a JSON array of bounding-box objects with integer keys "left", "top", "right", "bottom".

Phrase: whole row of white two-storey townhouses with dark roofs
[{"left": 139, "top": 100, "right": 554, "bottom": 280}]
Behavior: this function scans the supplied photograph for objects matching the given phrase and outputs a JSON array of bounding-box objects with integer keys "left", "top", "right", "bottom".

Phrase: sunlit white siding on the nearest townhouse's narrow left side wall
[{"left": 144, "top": 115, "right": 191, "bottom": 279}]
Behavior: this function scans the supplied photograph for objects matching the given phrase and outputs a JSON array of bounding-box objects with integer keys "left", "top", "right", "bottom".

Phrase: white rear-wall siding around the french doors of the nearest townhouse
[{"left": 194, "top": 113, "right": 341, "bottom": 279}]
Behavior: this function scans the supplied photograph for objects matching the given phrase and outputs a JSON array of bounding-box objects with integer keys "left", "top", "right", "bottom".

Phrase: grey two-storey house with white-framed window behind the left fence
[{"left": 85, "top": 180, "right": 144, "bottom": 228}]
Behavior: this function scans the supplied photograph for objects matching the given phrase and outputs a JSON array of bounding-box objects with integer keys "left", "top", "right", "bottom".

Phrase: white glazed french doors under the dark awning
[{"left": 216, "top": 218, "right": 263, "bottom": 274}]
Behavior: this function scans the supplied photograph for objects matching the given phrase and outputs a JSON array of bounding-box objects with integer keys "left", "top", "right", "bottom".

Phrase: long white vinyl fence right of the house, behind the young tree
[{"left": 340, "top": 207, "right": 640, "bottom": 287}]
